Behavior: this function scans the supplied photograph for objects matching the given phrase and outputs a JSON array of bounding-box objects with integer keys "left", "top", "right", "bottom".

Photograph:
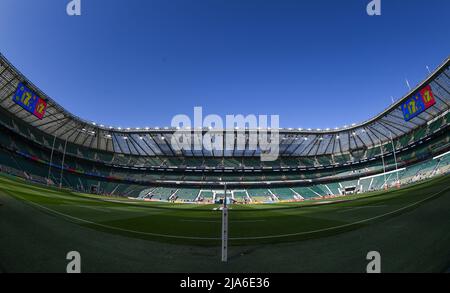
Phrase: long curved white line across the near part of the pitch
[{"left": 7, "top": 187, "right": 450, "bottom": 240}]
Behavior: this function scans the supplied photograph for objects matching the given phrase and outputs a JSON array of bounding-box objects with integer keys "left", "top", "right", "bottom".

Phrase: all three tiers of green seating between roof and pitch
[{"left": 0, "top": 93, "right": 450, "bottom": 201}]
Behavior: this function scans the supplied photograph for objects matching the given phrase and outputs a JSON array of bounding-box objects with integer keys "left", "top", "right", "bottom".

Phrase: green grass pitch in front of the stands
[{"left": 0, "top": 176, "right": 450, "bottom": 271}]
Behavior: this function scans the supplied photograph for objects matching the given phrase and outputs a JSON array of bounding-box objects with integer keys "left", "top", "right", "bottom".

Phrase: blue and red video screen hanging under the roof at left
[{"left": 13, "top": 83, "right": 47, "bottom": 120}]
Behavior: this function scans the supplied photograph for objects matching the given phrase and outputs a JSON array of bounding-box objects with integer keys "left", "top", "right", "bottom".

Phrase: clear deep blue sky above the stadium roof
[{"left": 0, "top": 0, "right": 450, "bottom": 128}]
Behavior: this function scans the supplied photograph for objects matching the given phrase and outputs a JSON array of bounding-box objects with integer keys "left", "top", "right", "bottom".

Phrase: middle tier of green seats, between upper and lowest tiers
[{"left": 0, "top": 124, "right": 450, "bottom": 191}]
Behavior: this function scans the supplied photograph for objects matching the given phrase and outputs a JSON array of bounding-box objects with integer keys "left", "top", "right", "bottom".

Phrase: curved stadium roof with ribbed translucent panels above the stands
[{"left": 0, "top": 54, "right": 450, "bottom": 157}]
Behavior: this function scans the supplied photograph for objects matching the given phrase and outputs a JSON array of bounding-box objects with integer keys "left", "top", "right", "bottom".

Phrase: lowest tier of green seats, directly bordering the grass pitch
[{"left": 0, "top": 149, "right": 450, "bottom": 202}]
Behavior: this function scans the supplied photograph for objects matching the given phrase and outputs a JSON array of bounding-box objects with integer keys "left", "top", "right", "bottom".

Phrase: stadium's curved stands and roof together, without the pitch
[{"left": 0, "top": 55, "right": 450, "bottom": 203}]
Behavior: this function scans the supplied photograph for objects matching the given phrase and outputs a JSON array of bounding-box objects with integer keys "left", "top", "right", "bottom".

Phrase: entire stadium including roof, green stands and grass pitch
[{"left": 0, "top": 50, "right": 450, "bottom": 272}]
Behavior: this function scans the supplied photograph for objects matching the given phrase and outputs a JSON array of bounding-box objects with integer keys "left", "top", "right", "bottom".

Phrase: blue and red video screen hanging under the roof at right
[{"left": 401, "top": 85, "right": 436, "bottom": 121}]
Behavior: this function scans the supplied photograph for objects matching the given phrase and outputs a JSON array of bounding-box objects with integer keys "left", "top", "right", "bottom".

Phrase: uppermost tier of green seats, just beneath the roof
[{"left": 0, "top": 105, "right": 450, "bottom": 168}]
